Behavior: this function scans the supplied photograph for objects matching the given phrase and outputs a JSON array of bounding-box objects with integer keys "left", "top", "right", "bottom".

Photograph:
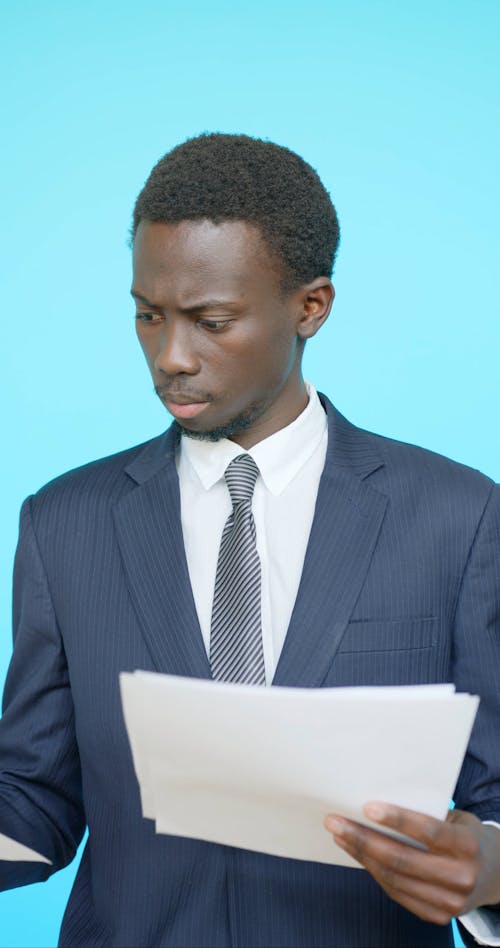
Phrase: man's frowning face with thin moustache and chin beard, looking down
[{"left": 132, "top": 221, "right": 328, "bottom": 447}]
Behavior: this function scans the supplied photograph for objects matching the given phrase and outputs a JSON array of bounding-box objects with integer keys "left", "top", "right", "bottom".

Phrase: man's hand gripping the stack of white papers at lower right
[{"left": 325, "top": 803, "right": 500, "bottom": 925}]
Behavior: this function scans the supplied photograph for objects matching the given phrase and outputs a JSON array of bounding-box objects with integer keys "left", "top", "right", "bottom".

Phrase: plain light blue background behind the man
[{"left": 0, "top": 0, "right": 500, "bottom": 948}]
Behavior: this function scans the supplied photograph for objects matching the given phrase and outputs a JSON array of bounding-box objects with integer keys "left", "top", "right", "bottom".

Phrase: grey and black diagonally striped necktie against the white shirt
[{"left": 210, "top": 454, "right": 266, "bottom": 685}]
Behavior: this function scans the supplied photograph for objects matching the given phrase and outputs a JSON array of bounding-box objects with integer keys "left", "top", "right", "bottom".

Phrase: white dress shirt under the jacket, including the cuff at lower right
[{"left": 177, "top": 382, "right": 500, "bottom": 945}]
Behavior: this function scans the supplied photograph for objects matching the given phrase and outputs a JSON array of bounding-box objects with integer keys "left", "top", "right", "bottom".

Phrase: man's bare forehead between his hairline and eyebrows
[{"left": 133, "top": 220, "right": 279, "bottom": 301}]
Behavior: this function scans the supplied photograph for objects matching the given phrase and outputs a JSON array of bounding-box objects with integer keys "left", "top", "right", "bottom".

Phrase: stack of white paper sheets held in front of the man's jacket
[{"left": 121, "top": 672, "right": 479, "bottom": 866}]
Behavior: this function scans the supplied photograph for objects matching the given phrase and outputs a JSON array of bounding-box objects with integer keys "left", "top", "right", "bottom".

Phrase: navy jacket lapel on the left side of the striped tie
[{"left": 114, "top": 426, "right": 211, "bottom": 678}]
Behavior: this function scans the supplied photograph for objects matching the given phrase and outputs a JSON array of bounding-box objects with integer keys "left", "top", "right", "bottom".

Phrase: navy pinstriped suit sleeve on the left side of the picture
[{"left": 0, "top": 499, "right": 85, "bottom": 890}]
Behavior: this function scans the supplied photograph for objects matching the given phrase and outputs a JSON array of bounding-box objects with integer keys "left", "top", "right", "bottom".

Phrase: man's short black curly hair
[{"left": 132, "top": 132, "right": 340, "bottom": 290}]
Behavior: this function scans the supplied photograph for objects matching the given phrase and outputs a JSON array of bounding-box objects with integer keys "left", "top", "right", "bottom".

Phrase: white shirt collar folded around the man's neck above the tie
[{"left": 180, "top": 382, "right": 327, "bottom": 495}]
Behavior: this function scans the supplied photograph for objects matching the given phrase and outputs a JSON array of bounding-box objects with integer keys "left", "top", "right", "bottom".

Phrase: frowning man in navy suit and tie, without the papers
[{"left": 0, "top": 135, "right": 500, "bottom": 948}]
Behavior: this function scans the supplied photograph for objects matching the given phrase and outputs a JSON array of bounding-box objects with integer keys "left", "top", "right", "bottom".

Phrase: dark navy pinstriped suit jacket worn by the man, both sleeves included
[{"left": 0, "top": 399, "right": 500, "bottom": 948}]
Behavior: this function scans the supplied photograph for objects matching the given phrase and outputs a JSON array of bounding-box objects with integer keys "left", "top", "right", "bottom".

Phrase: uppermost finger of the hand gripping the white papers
[{"left": 364, "top": 802, "right": 476, "bottom": 856}]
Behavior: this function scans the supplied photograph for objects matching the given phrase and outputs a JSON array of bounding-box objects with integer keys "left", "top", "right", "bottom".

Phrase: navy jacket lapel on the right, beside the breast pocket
[{"left": 273, "top": 398, "right": 387, "bottom": 687}]
